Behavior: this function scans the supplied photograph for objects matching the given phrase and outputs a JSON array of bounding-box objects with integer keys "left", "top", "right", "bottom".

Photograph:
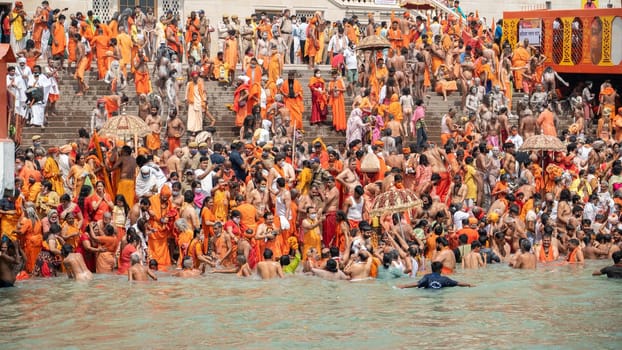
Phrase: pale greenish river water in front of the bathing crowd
[{"left": 0, "top": 261, "right": 622, "bottom": 349}]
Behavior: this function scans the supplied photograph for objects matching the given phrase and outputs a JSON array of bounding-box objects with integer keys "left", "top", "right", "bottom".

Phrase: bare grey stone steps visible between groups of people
[{"left": 17, "top": 65, "right": 572, "bottom": 151}]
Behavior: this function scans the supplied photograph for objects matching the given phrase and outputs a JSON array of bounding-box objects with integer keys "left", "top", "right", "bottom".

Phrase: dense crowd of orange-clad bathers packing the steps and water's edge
[{"left": 0, "top": 1, "right": 622, "bottom": 288}]
